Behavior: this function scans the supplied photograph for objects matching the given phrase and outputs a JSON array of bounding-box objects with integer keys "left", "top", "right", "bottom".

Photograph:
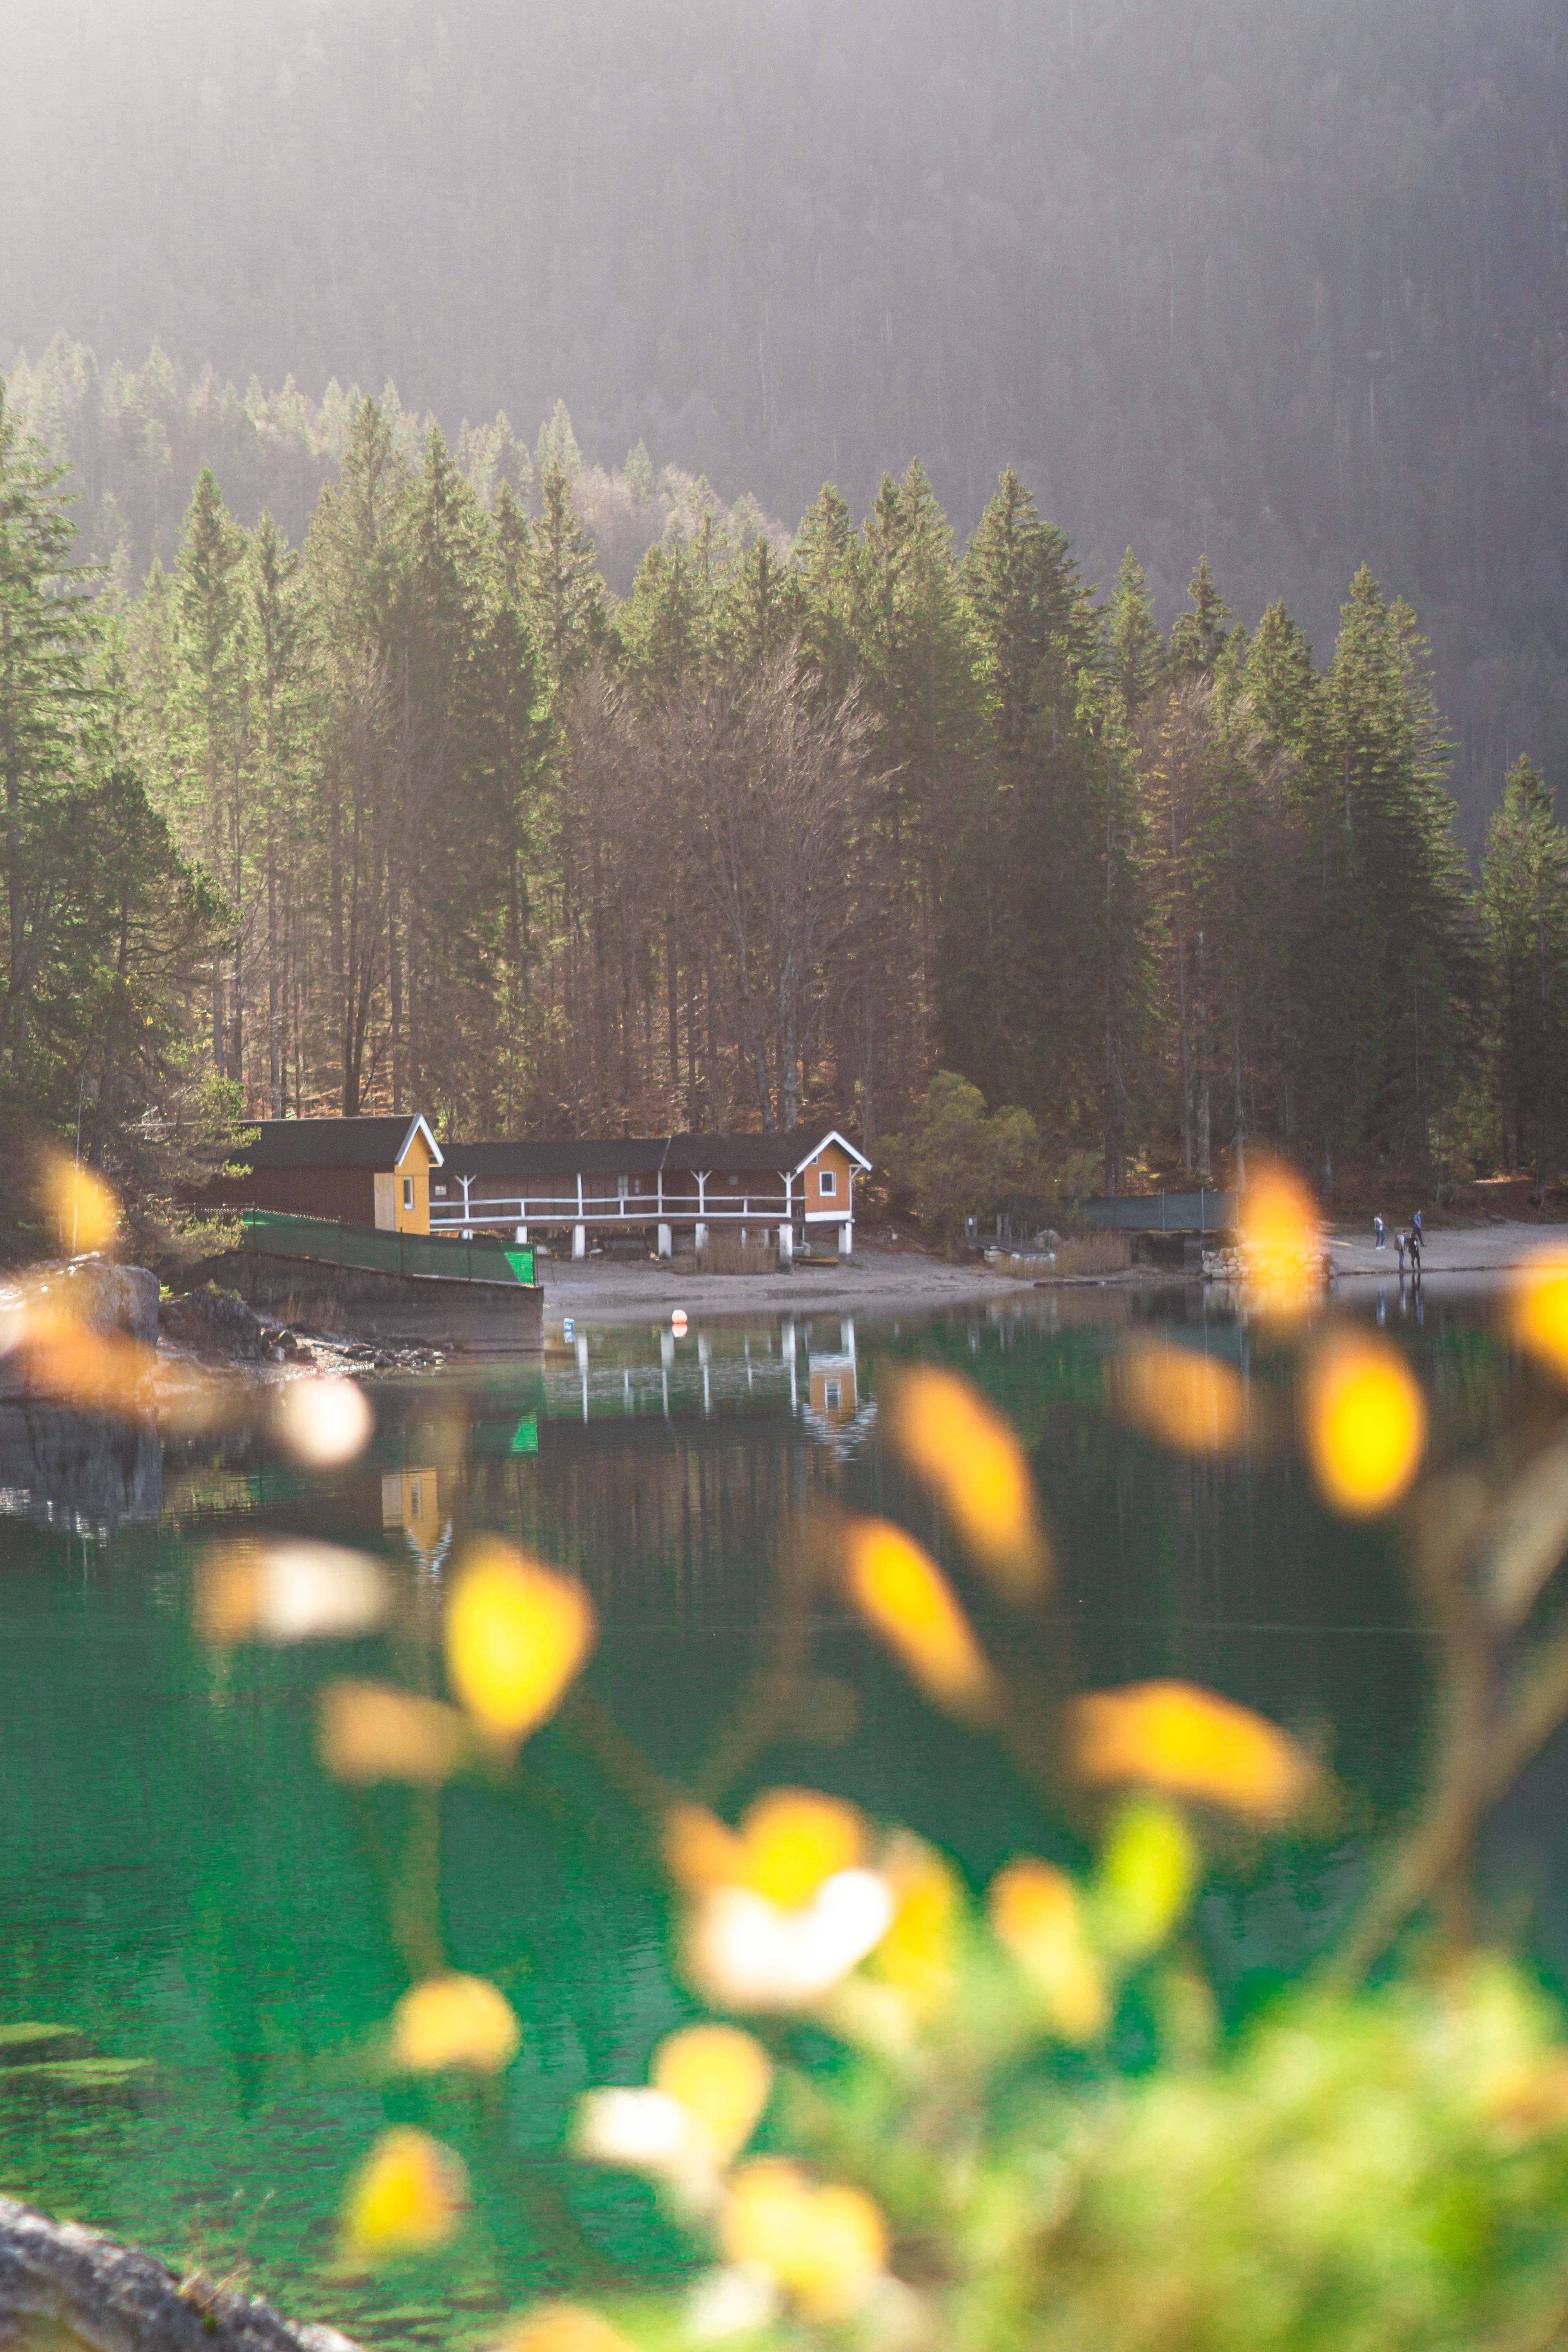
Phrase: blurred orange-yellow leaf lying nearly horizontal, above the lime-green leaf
[{"left": 1067, "top": 1682, "right": 1314, "bottom": 1820}]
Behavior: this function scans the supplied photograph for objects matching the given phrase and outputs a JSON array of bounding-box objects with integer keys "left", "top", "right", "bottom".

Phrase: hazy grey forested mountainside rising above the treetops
[{"left": 0, "top": 0, "right": 1568, "bottom": 847}]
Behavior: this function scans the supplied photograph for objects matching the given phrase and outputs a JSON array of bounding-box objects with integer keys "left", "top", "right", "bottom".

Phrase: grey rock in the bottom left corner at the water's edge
[{"left": 0, "top": 2197, "right": 355, "bottom": 2352}]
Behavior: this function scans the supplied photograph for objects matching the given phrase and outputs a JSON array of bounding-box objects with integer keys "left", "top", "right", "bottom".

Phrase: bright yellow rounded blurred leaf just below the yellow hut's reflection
[{"left": 446, "top": 1538, "right": 595, "bottom": 1743}]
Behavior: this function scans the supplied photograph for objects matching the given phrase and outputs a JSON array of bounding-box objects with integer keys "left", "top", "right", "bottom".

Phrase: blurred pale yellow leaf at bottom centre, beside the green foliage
[{"left": 722, "top": 2157, "right": 889, "bottom": 2321}]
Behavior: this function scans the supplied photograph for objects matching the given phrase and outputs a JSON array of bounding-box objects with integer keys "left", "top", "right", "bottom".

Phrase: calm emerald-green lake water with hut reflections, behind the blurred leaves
[{"left": 0, "top": 1284, "right": 1568, "bottom": 2345}]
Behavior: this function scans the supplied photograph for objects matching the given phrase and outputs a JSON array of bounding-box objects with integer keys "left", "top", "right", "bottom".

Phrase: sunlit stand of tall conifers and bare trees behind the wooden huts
[{"left": 0, "top": 360, "right": 1568, "bottom": 1251}]
